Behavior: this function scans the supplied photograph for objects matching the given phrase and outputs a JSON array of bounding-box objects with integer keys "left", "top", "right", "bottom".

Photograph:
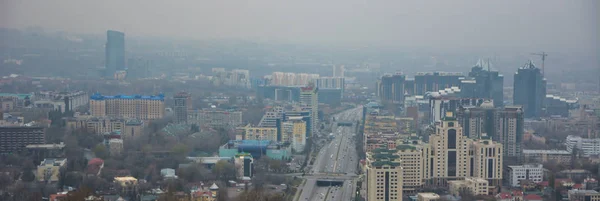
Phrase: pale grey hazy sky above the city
[{"left": 0, "top": 0, "right": 600, "bottom": 49}]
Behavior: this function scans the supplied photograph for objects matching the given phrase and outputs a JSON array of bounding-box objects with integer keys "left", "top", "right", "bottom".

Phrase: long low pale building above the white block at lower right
[{"left": 523, "top": 149, "right": 572, "bottom": 165}]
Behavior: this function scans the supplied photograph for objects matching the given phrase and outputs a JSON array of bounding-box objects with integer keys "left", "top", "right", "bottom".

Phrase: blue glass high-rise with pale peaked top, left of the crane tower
[{"left": 461, "top": 59, "right": 504, "bottom": 107}]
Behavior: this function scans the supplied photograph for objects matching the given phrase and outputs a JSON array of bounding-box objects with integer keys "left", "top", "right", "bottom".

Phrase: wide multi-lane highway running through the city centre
[{"left": 299, "top": 107, "right": 362, "bottom": 201}]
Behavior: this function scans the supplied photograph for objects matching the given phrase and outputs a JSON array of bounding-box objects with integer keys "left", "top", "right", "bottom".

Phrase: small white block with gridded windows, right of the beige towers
[{"left": 506, "top": 164, "right": 544, "bottom": 187}]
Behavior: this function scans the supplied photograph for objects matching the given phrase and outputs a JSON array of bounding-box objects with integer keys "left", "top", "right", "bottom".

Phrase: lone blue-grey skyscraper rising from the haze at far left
[{"left": 105, "top": 30, "right": 125, "bottom": 77}]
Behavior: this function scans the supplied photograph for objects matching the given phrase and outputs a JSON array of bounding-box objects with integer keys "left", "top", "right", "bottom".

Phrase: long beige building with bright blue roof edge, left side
[{"left": 90, "top": 93, "right": 165, "bottom": 120}]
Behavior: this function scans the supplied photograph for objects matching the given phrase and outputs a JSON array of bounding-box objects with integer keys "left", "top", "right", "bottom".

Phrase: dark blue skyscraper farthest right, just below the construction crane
[{"left": 513, "top": 60, "right": 546, "bottom": 118}]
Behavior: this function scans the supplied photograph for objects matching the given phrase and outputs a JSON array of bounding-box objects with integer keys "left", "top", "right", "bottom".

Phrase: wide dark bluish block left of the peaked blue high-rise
[{"left": 411, "top": 72, "right": 464, "bottom": 95}]
